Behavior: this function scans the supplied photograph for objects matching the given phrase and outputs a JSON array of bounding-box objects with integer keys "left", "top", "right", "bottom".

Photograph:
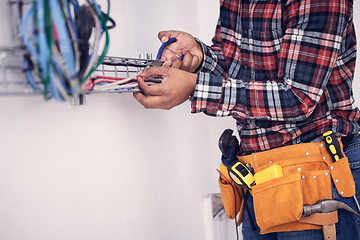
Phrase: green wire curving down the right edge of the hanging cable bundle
[{"left": 81, "top": 0, "right": 110, "bottom": 85}]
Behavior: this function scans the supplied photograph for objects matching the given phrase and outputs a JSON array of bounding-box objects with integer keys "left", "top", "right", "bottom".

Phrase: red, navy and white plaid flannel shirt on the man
[{"left": 192, "top": 0, "right": 360, "bottom": 153}]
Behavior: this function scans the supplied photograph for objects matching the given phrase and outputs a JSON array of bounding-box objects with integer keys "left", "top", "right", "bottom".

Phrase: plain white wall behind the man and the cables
[{"left": 0, "top": 0, "right": 360, "bottom": 240}]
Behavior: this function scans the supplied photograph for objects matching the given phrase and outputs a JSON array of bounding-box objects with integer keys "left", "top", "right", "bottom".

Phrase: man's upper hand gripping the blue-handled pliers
[{"left": 158, "top": 31, "right": 204, "bottom": 72}]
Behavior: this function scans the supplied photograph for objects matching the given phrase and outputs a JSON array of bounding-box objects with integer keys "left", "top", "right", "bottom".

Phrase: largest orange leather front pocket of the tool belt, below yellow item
[{"left": 252, "top": 174, "right": 303, "bottom": 229}]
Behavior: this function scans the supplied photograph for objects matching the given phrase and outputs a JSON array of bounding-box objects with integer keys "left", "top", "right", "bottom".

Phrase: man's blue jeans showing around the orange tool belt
[{"left": 242, "top": 137, "right": 360, "bottom": 240}]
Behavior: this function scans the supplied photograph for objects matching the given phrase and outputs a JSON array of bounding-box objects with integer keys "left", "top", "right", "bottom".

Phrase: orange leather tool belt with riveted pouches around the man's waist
[{"left": 219, "top": 142, "right": 355, "bottom": 234}]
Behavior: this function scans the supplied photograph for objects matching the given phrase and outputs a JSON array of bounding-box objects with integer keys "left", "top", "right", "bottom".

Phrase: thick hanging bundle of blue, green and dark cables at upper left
[{"left": 20, "top": 0, "right": 110, "bottom": 101}]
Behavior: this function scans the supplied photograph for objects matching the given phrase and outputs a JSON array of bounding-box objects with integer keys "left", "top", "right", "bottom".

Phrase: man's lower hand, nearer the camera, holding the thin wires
[{"left": 134, "top": 67, "right": 197, "bottom": 110}]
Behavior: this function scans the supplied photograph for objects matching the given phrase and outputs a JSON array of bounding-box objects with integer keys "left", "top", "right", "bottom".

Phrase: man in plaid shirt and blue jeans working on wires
[{"left": 134, "top": 0, "right": 360, "bottom": 239}]
